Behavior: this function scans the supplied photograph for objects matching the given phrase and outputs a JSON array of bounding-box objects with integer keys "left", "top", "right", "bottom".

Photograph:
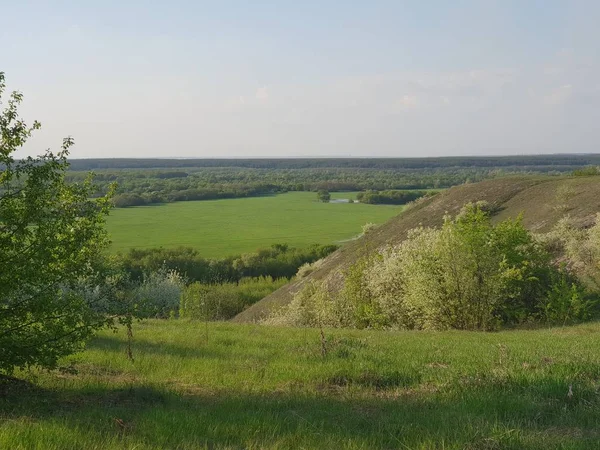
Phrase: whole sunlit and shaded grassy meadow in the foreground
[{"left": 0, "top": 320, "right": 600, "bottom": 450}]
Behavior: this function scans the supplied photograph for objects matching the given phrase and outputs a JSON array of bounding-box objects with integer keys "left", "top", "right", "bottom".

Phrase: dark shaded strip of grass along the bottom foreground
[{"left": 0, "top": 372, "right": 600, "bottom": 449}]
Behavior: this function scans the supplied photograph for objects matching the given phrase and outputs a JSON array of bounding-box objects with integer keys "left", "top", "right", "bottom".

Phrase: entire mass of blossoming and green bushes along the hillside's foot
[{"left": 270, "top": 204, "right": 593, "bottom": 330}]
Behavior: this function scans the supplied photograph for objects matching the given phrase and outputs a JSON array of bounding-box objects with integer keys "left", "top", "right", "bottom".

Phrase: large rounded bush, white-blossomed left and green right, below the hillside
[{"left": 368, "top": 204, "right": 556, "bottom": 330}]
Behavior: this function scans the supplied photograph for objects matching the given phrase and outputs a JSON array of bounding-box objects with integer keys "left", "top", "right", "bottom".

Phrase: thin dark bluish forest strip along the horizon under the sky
[{"left": 71, "top": 154, "right": 600, "bottom": 170}]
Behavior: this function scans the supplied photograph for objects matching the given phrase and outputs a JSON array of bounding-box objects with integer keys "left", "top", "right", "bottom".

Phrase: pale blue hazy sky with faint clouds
[{"left": 0, "top": 0, "right": 600, "bottom": 158}]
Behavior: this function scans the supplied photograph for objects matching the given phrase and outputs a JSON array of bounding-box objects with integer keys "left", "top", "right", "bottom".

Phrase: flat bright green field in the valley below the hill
[{"left": 107, "top": 192, "right": 402, "bottom": 258}]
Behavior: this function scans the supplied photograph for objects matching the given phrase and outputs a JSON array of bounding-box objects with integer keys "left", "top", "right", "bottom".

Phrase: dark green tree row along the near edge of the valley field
[{"left": 116, "top": 244, "right": 338, "bottom": 284}]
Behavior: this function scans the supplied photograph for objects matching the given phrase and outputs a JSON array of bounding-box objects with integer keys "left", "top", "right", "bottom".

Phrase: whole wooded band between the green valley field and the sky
[{"left": 59, "top": 155, "right": 600, "bottom": 207}]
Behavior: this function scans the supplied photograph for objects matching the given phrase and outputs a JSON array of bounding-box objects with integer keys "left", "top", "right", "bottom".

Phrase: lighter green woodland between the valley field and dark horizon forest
[{"left": 68, "top": 168, "right": 561, "bottom": 207}]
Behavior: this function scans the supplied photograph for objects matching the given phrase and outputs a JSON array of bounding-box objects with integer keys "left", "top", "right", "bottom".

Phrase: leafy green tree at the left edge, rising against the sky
[{"left": 0, "top": 72, "right": 112, "bottom": 373}]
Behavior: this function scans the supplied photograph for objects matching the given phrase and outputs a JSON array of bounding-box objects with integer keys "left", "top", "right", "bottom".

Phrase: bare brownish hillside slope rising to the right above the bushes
[{"left": 233, "top": 177, "right": 600, "bottom": 322}]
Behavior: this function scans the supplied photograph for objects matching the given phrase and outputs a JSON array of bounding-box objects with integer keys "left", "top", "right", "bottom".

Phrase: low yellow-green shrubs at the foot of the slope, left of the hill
[{"left": 180, "top": 277, "right": 288, "bottom": 320}]
